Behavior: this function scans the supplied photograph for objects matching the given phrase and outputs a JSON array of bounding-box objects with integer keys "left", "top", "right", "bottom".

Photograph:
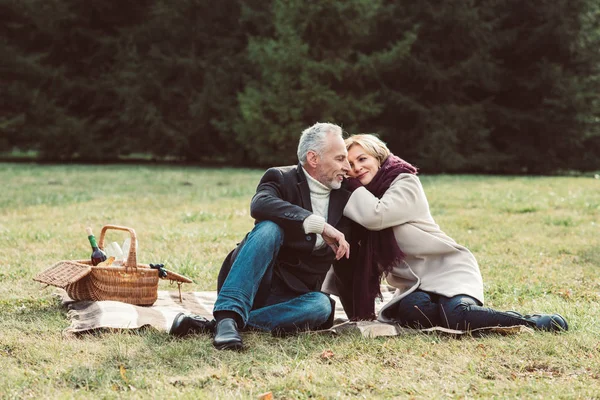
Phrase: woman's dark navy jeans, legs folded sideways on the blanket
[{"left": 386, "top": 290, "right": 535, "bottom": 330}]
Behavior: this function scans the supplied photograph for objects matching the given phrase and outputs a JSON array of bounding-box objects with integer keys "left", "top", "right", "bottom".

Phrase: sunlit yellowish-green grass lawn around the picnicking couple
[{"left": 0, "top": 164, "right": 600, "bottom": 399}]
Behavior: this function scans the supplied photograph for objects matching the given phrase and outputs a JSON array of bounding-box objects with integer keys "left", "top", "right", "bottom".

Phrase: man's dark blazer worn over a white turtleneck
[{"left": 217, "top": 165, "right": 352, "bottom": 316}]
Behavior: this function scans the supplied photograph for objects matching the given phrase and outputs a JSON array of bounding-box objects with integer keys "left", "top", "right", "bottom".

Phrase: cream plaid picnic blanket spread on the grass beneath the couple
[{"left": 58, "top": 286, "right": 533, "bottom": 337}]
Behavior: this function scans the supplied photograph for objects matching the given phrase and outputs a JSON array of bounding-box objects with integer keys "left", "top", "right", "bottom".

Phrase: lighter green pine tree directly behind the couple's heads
[{"left": 235, "top": 0, "right": 392, "bottom": 165}]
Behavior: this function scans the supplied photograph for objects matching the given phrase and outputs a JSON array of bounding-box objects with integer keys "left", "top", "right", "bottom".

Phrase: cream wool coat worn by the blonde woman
[{"left": 344, "top": 174, "right": 483, "bottom": 322}]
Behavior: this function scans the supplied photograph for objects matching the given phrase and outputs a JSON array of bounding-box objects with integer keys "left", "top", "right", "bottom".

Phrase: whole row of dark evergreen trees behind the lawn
[{"left": 0, "top": 0, "right": 600, "bottom": 173}]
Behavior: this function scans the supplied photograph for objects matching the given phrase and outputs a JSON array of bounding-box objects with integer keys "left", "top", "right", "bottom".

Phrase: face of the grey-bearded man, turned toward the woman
[{"left": 315, "top": 133, "right": 350, "bottom": 189}]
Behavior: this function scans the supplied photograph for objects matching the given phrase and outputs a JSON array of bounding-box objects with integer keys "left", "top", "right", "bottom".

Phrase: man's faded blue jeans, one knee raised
[{"left": 213, "top": 221, "right": 332, "bottom": 332}]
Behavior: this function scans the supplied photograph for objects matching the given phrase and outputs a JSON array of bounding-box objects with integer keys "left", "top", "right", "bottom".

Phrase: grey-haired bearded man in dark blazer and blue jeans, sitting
[{"left": 171, "top": 123, "right": 351, "bottom": 349}]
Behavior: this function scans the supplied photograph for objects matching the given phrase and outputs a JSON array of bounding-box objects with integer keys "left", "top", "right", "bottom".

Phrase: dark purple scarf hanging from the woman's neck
[{"left": 348, "top": 154, "right": 417, "bottom": 320}]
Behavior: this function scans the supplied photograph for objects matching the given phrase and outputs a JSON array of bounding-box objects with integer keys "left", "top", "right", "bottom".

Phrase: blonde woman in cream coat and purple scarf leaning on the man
[{"left": 344, "top": 134, "right": 568, "bottom": 331}]
